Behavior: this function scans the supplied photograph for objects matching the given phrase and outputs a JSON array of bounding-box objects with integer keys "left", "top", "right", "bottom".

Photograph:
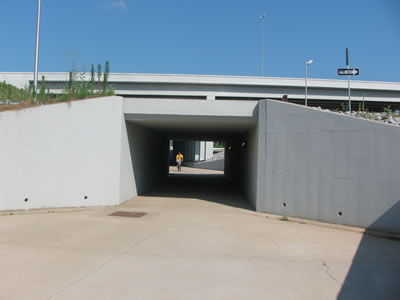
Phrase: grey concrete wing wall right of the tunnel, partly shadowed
[{"left": 257, "top": 100, "right": 400, "bottom": 232}]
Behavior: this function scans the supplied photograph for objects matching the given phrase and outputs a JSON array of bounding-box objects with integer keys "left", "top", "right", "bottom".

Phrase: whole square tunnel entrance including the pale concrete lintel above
[{"left": 125, "top": 99, "right": 258, "bottom": 208}]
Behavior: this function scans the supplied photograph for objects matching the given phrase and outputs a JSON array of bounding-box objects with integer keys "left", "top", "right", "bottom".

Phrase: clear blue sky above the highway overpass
[{"left": 0, "top": 0, "right": 400, "bottom": 82}]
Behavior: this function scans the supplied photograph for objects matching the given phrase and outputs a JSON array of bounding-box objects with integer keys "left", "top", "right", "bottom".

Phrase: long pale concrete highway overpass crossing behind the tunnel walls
[{"left": 0, "top": 72, "right": 400, "bottom": 111}]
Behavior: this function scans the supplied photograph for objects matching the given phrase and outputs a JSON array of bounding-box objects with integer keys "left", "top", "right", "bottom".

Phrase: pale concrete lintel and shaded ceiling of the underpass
[{"left": 124, "top": 99, "right": 258, "bottom": 139}]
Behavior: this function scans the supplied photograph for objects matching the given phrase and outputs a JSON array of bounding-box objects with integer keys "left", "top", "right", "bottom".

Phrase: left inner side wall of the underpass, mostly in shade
[{"left": 120, "top": 122, "right": 169, "bottom": 197}]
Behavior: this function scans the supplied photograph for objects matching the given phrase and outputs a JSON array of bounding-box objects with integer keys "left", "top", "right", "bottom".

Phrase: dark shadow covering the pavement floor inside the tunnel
[{"left": 146, "top": 174, "right": 254, "bottom": 211}]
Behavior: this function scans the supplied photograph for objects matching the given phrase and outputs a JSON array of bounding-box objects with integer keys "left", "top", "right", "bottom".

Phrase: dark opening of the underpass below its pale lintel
[{"left": 127, "top": 122, "right": 254, "bottom": 210}]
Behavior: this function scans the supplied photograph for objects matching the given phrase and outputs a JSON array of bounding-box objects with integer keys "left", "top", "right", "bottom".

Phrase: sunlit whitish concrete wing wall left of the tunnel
[{"left": 0, "top": 97, "right": 123, "bottom": 210}]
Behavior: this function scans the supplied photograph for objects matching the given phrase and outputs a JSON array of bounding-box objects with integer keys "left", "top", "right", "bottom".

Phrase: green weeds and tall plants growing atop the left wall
[{"left": 0, "top": 61, "right": 114, "bottom": 111}]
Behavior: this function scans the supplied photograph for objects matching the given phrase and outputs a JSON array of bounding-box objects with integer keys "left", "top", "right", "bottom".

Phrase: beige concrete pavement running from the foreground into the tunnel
[{"left": 0, "top": 170, "right": 400, "bottom": 299}]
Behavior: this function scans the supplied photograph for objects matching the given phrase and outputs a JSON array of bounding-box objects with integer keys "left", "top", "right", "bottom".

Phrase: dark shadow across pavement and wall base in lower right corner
[{"left": 338, "top": 201, "right": 400, "bottom": 300}]
